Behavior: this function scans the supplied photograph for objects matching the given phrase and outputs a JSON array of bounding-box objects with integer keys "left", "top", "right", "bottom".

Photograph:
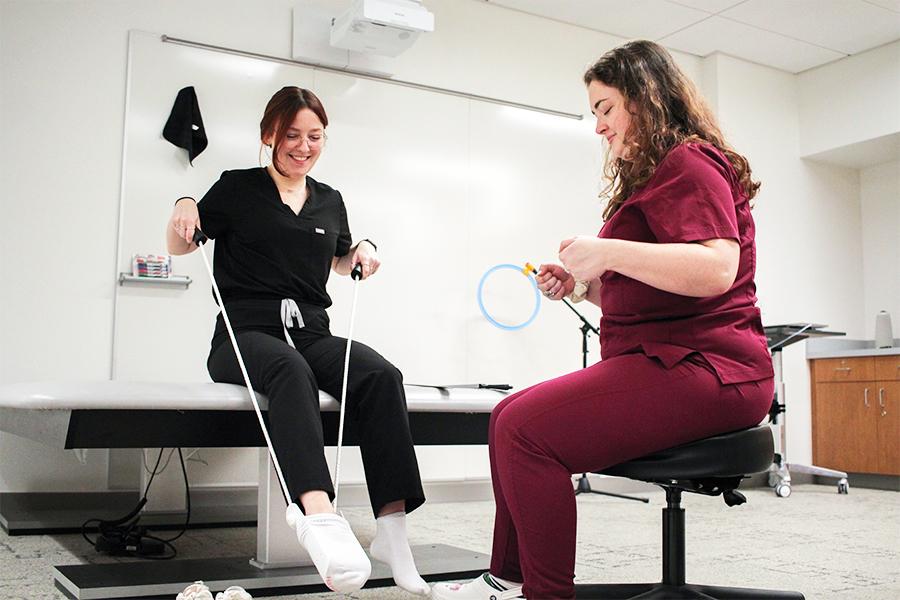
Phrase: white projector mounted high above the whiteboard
[{"left": 331, "top": 0, "right": 434, "bottom": 56}]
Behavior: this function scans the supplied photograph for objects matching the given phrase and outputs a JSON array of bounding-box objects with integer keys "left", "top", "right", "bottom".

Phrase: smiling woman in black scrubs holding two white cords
[{"left": 167, "top": 87, "right": 429, "bottom": 595}]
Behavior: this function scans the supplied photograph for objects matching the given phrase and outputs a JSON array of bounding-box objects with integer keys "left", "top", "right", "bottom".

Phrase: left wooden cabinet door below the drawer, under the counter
[{"left": 813, "top": 383, "right": 878, "bottom": 473}]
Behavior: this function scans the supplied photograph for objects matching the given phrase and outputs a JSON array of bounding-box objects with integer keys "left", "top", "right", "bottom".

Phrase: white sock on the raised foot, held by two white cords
[{"left": 286, "top": 504, "right": 372, "bottom": 593}]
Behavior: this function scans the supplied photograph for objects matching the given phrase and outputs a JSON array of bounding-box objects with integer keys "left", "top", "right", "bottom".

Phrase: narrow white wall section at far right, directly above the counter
[{"left": 860, "top": 160, "right": 900, "bottom": 339}]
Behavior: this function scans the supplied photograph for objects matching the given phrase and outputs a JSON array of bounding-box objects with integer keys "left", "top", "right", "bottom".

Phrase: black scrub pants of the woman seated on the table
[{"left": 207, "top": 328, "right": 425, "bottom": 517}]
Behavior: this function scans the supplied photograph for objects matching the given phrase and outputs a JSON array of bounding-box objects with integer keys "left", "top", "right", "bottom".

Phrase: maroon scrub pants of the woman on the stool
[{"left": 489, "top": 354, "right": 774, "bottom": 600}]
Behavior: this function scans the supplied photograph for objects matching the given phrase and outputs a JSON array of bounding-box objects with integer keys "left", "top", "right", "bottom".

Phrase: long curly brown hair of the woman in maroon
[{"left": 584, "top": 40, "right": 759, "bottom": 221}]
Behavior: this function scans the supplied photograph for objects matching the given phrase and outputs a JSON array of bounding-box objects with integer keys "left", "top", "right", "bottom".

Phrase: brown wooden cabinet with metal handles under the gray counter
[{"left": 810, "top": 355, "right": 900, "bottom": 475}]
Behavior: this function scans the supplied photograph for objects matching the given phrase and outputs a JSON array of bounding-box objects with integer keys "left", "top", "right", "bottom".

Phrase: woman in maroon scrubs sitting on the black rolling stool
[{"left": 433, "top": 41, "right": 774, "bottom": 600}]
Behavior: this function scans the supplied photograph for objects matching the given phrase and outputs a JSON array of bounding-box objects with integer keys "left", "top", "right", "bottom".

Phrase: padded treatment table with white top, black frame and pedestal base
[{"left": 0, "top": 381, "right": 505, "bottom": 600}]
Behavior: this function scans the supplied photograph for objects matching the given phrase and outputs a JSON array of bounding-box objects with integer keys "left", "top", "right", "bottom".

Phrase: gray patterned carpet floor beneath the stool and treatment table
[{"left": 0, "top": 484, "right": 900, "bottom": 600}]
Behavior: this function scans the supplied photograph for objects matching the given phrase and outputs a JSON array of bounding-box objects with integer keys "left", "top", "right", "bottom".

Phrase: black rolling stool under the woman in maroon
[{"left": 575, "top": 425, "right": 804, "bottom": 600}]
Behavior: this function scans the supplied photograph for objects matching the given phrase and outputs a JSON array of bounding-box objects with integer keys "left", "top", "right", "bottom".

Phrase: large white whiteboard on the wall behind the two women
[{"left": 114, "top": 32, "right": 602, "bottom": 488}]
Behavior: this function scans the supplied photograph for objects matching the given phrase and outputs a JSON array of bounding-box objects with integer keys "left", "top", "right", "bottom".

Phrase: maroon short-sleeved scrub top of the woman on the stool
[{"left": 599, "top": 142, "right": 773, "bottom": 384}]
